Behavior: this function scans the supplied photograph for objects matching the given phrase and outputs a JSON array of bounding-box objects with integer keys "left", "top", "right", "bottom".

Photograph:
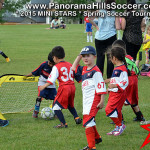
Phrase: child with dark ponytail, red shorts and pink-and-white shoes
[{"left": 105, "top": 47, "right": 128, "bottom": 136}]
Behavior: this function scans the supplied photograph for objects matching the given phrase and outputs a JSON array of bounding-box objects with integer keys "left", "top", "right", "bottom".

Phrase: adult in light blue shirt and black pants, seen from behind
[{"left": 90, "top": 0, "right": 121, "bottom": 78}]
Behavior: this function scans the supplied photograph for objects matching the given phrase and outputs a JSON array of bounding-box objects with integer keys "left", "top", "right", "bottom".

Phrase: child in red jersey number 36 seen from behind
[{"left": 40, "top": 46, "right": 82, "bottom": 128}]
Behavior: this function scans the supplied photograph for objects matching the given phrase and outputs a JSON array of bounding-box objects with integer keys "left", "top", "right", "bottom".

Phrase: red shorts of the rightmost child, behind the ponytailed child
[{"left": 126, "top": 75, "right": 139, "bottom": 105}]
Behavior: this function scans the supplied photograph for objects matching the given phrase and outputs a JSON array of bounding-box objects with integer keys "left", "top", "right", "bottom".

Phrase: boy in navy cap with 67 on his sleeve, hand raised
[{"left": 72, "top": 46, "right": 106, "bottom": 150}]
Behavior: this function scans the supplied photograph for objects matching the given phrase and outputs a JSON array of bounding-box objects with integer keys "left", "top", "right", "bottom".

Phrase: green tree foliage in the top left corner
[{"left": 0, "top": 0, "right": 30, "bottom": 23}]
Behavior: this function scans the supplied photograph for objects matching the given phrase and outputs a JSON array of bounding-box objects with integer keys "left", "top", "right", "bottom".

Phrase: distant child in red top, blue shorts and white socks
[{"left": 84, "top": 16, "right": 93, "bottom": 42}]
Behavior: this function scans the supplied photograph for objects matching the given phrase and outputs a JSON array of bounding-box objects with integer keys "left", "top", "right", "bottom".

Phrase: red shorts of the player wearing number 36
[{"left": 53, "top": 84, "right": 76, "bottom": 109}]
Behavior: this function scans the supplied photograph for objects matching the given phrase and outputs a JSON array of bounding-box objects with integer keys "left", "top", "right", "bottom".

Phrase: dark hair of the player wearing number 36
[{"left": 52, "top": 46, "right": 65, "bottom": 59}]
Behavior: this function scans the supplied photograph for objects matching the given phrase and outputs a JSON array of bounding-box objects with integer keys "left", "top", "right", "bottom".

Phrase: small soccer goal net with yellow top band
[{"left": 0, "top": 74, "right": 52, "bottom": 113}]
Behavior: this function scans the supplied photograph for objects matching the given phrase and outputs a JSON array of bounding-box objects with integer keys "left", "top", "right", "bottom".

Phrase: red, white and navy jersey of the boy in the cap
[{"left": 75, "top": 66, "right": 106, "bottom": 115}]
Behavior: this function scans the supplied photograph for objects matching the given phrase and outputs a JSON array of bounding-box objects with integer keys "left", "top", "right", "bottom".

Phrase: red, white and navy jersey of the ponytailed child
[{"left": 108, "top": 65, "right": 129, "bottom": 92}]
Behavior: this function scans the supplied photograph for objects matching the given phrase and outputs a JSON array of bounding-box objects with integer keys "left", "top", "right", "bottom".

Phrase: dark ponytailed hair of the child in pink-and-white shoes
[{"left": 110, "top": 46, "right": 131, "bottom": 76}]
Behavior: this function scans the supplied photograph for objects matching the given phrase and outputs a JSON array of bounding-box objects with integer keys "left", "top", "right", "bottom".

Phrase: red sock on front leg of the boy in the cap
[{"left": 85, "top": 127, "right": 95, "bottom": 149}]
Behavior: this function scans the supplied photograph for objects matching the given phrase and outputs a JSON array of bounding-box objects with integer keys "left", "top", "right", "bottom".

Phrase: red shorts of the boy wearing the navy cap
[{"left": 83, "top": 95, "right": 101, "bottom": 127}]
